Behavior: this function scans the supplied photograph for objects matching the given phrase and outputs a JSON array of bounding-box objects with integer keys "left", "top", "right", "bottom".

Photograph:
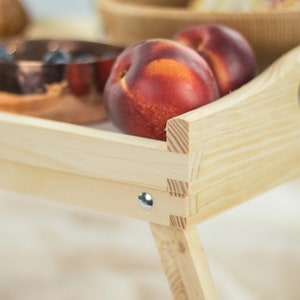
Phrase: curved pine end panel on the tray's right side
[{"left": 167, "top": 47, "right": 300, "bottom": 223}]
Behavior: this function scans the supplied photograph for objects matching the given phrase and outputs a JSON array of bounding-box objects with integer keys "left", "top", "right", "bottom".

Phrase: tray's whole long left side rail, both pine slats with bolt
[{"left": 0, "top": 112, "right": 189, "bottom": 227}]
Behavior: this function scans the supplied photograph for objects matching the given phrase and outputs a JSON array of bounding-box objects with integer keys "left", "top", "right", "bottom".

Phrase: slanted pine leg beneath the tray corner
[{"left": 150, "top": 224, "right": 217, "bottom": 300}]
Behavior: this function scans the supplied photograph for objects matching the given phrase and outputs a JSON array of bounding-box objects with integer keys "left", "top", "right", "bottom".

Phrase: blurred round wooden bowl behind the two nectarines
[{"left": 96, "top": 0, "right": 300, "bottom": 68}]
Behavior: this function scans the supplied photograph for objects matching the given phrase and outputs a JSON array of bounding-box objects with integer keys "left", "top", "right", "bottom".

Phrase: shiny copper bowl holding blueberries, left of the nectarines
[{"left": 0, "top": 40, "right": 122, "bottom": 124}]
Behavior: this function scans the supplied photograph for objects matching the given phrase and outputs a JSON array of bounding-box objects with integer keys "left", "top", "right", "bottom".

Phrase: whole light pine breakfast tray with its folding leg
[{"left": 0, "top": 46, "right": 300, "bottom": 300}]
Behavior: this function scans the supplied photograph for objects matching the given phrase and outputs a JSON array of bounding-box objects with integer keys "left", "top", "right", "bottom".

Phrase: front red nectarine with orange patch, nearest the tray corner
[{"left": 103, "top": 39, "right": 219, "bottom": 140}]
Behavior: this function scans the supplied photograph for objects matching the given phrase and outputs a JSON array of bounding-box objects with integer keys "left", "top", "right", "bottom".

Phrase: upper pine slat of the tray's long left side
[{"left": 0, "top": 113, "right": 188, "bottom": 191}]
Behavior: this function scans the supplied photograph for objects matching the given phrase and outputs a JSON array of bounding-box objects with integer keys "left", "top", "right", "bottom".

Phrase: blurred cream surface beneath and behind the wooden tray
[{"left": 0, "top": 14, "right": 300, "bottom": 300}]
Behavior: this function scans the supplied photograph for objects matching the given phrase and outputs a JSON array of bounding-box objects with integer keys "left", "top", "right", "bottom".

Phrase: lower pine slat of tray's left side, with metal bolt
[{"left": 0, "top": 159, "right": 188, "bottom": 226}]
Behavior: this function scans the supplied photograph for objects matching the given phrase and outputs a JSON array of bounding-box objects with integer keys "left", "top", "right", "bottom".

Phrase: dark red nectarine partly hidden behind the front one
[{"left": 173, "top": 24, "right": 257, "bottom": 96}]
